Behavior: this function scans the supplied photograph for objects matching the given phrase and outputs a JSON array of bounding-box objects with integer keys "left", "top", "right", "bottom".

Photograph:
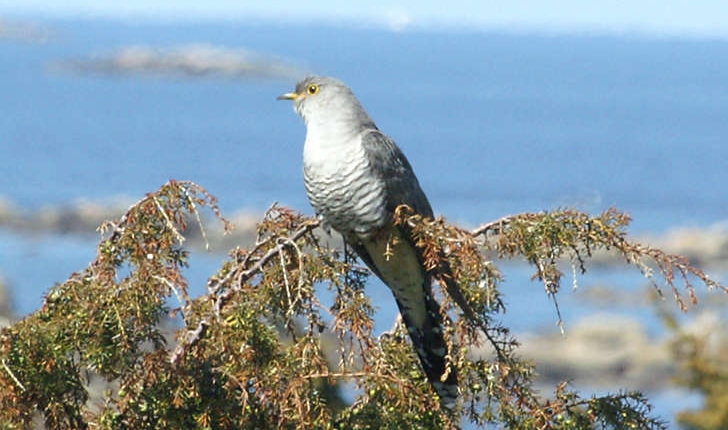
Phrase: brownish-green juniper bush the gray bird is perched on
[{"left": 0, "top": 181, "right": 723, "bottom": 429}]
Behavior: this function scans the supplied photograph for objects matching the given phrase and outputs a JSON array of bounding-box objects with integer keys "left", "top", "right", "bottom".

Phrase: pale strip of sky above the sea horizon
[{"left": 0, "top": 0, "right": 728, "bottom": 39}]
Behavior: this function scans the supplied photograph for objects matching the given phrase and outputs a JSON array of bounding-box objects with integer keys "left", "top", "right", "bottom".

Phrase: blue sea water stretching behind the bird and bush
[{"left": 0, "top": 19, "right": 728, "bottom": 424}]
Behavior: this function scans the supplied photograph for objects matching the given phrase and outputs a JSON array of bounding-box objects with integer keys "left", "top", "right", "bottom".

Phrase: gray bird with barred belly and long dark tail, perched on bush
[{"left": 278, "top": 76, "right": 458, "bottom": 407}]
